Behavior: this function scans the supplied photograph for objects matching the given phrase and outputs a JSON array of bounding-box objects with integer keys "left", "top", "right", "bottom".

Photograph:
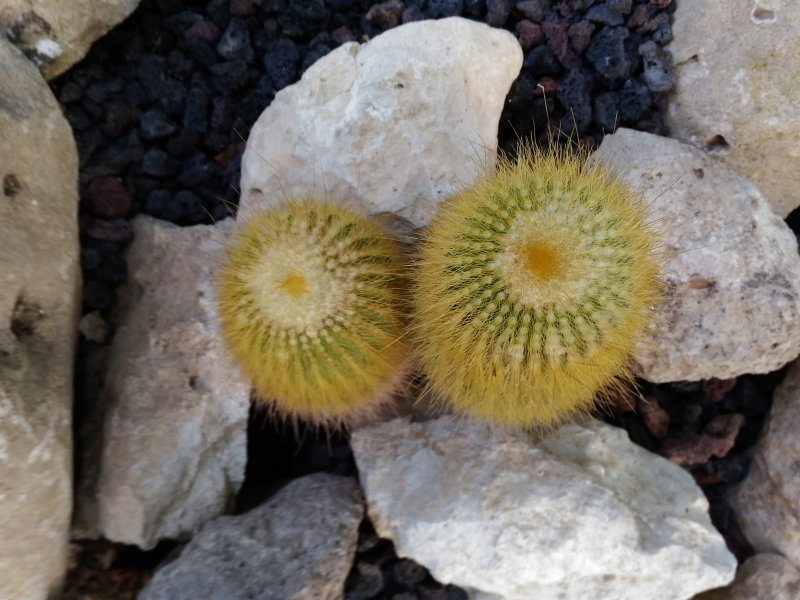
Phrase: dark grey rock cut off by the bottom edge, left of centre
[{"left": 139, "top": 473, "right": 364, "bottom": 600}]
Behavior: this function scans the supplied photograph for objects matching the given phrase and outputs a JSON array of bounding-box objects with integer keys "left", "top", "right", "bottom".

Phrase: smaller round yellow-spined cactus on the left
[{"left": 219, "top": 200, "right": 408, "bottom": 427}]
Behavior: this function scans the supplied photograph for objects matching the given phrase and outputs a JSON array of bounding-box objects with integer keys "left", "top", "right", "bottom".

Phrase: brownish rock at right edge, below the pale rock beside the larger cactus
[{"left": 730, "top": 362, "right": 800, "bottom": 568}]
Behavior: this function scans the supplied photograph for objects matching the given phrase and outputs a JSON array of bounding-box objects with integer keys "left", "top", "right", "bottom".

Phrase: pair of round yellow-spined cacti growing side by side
[{"left": 220, "top": 149, "right": 660, "bottom": 427}]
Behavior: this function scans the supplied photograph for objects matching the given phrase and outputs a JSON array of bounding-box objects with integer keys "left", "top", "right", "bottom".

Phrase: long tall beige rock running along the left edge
[{"left": 0, "top": 38, "right": 81, "bottom": 600}]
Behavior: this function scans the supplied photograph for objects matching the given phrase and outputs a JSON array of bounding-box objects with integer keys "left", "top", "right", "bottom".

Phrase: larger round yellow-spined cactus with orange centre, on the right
[{"left": 413, "top": 147, "right": 661, "bottom": 427}]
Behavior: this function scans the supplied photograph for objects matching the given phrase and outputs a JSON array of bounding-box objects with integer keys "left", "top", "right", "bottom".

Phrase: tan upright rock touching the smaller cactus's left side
[{"left": 76, "top": 217, "right": 250, "bottom": 549}]
